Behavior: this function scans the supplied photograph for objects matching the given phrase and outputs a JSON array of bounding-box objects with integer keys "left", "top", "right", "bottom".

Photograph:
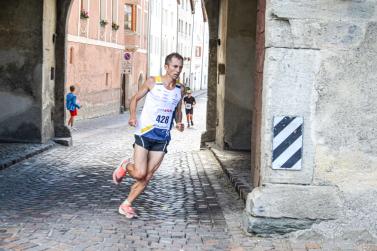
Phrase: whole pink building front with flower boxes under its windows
[{"left": 65, "top": 0, "right": 125, "bottom": 119}]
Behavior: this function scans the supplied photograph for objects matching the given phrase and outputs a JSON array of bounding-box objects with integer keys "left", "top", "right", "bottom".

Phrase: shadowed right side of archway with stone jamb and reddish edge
[{"left": 202, "top": 0, "right": 265, "bottom": 186}]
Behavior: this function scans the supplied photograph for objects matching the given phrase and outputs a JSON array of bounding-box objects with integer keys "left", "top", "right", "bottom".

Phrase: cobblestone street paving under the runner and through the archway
[{"left": 0, "top": 91, "right": 375, "bottom": 251}]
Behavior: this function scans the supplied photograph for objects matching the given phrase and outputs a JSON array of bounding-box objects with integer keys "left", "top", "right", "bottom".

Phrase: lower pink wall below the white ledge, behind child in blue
[{"left": 66, "top": 42, "right": 123, "bottom": 119}]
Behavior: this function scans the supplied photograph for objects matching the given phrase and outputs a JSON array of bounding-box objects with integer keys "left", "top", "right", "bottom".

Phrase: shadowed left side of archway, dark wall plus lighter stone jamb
[{"left": 0, "top": 0, "right": 78, "bottom": 143}]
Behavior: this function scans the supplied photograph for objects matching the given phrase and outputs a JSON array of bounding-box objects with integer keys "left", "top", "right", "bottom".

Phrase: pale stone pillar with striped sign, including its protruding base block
[{"left": 244, "top": 0, "right": 377, "bottom": 233}]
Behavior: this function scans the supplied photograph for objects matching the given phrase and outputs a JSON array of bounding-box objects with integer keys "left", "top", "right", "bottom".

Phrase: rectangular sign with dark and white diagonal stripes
[{"left": 272, "top": 116, "right": 304, "bottom": 170}]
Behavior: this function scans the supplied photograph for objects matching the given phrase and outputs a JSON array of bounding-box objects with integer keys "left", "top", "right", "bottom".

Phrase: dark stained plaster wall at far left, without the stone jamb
[{"left": 0, "top": 0, "right": 44, "bottom": 142}]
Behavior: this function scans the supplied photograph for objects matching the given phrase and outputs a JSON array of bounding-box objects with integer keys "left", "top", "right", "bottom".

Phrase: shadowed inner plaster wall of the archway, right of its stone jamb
[{"left": 223, "top": 0, "right": 257, "bottom": 150}]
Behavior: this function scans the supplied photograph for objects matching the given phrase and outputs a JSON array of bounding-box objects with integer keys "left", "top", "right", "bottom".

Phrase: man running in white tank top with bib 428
[{"left": 113, "top": 53, "right": 185, "bottom": 218}]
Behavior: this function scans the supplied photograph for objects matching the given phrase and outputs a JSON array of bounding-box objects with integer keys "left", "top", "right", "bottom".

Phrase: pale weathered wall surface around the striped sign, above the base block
[{"left": 261, "top": 0, "right": 377, "bottom": 184}]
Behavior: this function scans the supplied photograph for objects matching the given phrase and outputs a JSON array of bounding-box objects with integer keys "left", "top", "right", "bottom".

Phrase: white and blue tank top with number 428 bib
[{"left": 135, "top": 76, "right": 182, "bottom": 142}]
